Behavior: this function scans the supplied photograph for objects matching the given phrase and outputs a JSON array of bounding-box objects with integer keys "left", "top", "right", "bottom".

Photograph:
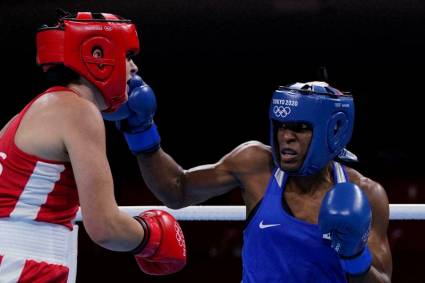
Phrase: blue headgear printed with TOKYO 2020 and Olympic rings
[{"left": 269, "top": 82, "right": 354, "bottom": 175}]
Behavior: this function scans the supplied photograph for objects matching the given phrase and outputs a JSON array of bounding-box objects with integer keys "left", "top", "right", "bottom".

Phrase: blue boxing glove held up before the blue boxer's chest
[{"left": 319, "top": 183, "right": 372, "bottom": 276}]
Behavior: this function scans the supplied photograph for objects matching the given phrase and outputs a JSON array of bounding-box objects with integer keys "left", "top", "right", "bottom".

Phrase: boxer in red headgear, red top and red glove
[{"left": 0, "top": 12, "right": 186, "bottom": 283}]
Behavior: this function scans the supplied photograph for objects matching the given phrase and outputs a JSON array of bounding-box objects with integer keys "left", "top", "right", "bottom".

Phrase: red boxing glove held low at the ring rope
[{"left": 133, "top": 210, "right": 186, "bottom": 275}]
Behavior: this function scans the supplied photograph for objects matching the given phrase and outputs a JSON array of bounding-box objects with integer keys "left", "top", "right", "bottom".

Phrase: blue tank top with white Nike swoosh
[{"left": 242, "top": 162, "right": 348, "bottom": 283}]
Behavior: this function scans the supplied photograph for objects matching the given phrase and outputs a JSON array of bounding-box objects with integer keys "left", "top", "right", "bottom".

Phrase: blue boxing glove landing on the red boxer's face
[{"left": 102, "top": 75, "right": 161, "bottom": 154}]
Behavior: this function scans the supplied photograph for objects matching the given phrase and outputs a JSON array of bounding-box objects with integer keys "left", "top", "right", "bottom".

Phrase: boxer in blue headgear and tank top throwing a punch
[{"left": 108, "top": 82, "right": 392, "bottom": 283}]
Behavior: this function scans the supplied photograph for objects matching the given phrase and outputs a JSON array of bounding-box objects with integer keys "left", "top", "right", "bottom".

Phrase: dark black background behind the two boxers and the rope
[{"left": 0, "top": 0, "right": 425, "bottom": 282}]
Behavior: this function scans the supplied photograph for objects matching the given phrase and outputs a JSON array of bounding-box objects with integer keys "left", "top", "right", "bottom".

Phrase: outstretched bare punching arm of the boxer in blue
[{"left": 138, "top": 142, "right": 271, "bottom": 208}]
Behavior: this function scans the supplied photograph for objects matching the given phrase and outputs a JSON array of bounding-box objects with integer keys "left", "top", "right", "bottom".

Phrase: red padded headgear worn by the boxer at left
[{"left": 36, "top": 12, "right": 139, "bottom": 112}]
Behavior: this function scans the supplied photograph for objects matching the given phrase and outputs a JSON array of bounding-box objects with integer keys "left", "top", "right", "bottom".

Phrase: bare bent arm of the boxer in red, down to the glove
[{"left": 61, "top": 96, "right": 143, "bottom": 251}]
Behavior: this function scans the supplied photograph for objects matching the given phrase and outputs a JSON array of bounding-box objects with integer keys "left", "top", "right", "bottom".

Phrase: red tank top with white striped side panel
[{"left": 0, "top": 87, "right": 79, "bottom": 230}]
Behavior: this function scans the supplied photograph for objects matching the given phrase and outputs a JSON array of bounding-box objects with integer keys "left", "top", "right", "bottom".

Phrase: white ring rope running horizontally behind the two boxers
[{"left": 76, "top": 204, "right": 425, "bottom": 221}]
